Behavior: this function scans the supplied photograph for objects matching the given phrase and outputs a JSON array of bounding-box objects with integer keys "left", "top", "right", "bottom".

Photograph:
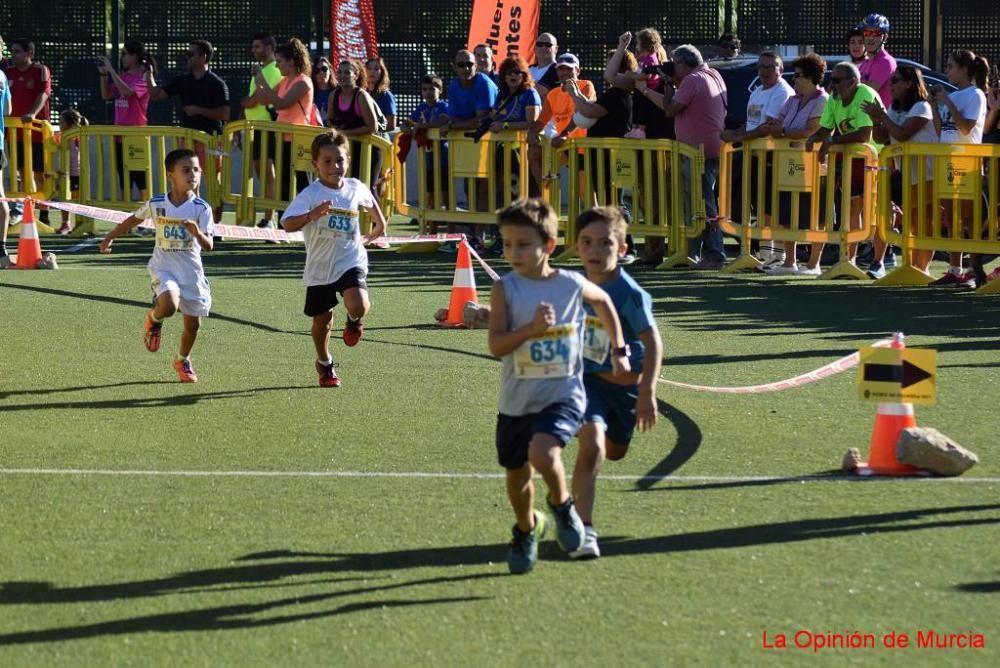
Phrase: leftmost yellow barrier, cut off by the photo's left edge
[{"left": 0, "top": 116, "right": 56, "bottom": 234}]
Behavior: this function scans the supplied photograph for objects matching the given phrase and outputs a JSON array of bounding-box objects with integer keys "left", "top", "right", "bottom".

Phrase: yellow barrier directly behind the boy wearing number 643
[{"left": 58, "top": 125, "right": 221, "bottom": 235}]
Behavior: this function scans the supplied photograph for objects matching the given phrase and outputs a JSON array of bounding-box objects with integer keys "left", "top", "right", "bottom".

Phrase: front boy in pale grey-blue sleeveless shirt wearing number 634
[{"left": 489, "top": 199, "right": 629, "bottom": 574}]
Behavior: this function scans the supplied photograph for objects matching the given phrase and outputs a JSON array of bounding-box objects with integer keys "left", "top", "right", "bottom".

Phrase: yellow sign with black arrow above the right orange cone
[{"left": 858, "top": 347, "right": 937, "bottom": 405}]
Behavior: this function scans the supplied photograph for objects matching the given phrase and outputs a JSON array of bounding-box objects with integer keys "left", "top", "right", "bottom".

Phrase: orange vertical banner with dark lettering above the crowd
[{"left": 466, "top": 0, "right": 539, "bottom": 63}]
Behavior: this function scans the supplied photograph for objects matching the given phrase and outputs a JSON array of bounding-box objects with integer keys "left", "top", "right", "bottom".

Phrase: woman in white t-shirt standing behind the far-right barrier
[{"left": 931, "top": 49, "right": 990, "bottom": 288}]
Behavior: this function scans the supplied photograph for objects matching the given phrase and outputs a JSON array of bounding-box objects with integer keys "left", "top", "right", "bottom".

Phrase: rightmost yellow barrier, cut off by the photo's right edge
[{"left": 877, "top": 142, "right": 1000, "bottom": 294}]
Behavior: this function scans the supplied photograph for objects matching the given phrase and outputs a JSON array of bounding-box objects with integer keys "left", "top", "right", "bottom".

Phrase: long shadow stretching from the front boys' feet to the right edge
[{"left": 601, "top": 504, "right": 1000, "bottom": 557}]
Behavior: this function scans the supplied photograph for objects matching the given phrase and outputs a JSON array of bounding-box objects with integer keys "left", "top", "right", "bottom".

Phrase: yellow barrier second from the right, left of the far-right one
[{"left": 719, "top": 139, "right": 878, "bottom": 279}]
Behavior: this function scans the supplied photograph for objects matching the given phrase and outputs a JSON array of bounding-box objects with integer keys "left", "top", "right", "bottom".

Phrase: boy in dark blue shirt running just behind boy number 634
[{"left": 570, "top": 206, "right": 663, "bottom": 559}]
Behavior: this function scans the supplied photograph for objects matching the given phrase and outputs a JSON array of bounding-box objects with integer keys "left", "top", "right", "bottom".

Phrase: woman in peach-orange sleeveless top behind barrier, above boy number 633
[{"left": 254, "top": 37, "right": 315, "bottom": 201}]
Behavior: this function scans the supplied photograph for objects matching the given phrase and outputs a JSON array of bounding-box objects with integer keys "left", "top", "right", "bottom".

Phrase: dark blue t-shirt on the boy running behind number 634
[{"left": 583, "top": 269, "right": 656, "bottom": 373}]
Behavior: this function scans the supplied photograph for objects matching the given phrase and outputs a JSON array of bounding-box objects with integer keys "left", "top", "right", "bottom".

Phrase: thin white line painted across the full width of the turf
[{"left": 0, "top": 468, "right": 1000, "bottom": 483}]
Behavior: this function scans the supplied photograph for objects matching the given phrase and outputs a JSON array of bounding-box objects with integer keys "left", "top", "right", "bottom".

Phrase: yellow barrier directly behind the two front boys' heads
[{"left": 546, "top": 137, "right": 705, "bottom": 267}]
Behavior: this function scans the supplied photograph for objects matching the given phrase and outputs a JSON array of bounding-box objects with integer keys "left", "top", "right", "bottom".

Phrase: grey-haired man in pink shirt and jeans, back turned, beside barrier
[{"left": 654, "top": 44, "right": 727, "bottom": 269}]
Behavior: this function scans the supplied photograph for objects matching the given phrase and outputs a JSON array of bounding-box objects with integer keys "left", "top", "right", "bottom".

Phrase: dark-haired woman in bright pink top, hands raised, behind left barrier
[{"left": 98, "top": 41, "right": 156, "bottom": 201}]
